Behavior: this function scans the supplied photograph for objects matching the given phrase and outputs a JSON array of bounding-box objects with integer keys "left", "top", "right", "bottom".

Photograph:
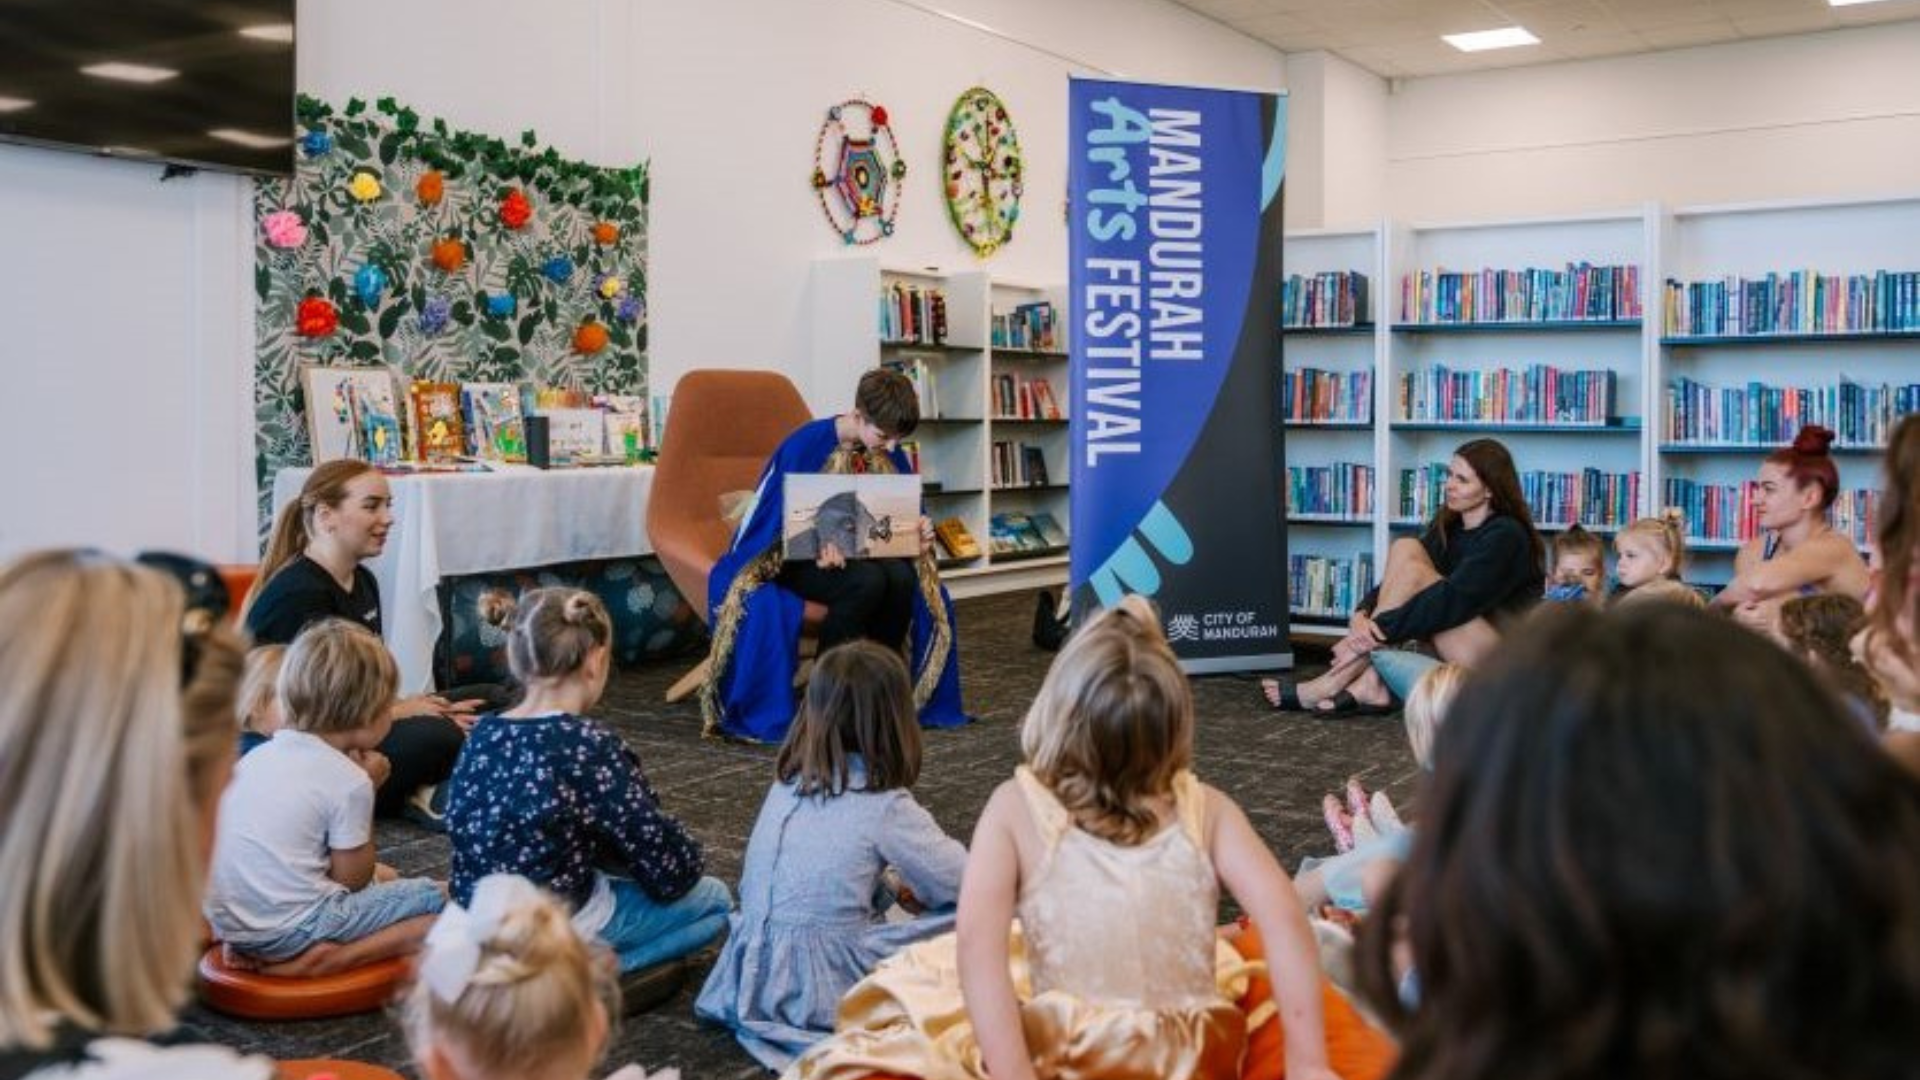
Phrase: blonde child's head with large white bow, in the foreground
[{"left": 405, "top": 874, "right": 680, "bottom": 1080}]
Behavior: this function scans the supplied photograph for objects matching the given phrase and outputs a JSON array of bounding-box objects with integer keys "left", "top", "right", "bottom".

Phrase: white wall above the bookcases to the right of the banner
[{"left": 1382, "top": 23, "right": 1920, "bottom": 221}]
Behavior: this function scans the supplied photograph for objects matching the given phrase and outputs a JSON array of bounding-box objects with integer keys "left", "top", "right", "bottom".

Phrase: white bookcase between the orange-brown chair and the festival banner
[{"left": 810, "top": 256, "right": 1071, "bottom": 596}]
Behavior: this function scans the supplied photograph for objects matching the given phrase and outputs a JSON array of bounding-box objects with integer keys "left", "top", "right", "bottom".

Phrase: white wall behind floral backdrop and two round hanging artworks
[{"left": 0, "top": 0, "right": 1286, "bottom": 561}]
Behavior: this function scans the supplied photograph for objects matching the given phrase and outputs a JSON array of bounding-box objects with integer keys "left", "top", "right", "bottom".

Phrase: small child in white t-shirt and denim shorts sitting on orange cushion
[{"left": 205, "top": 619, "right": 445, "bottom": 976}]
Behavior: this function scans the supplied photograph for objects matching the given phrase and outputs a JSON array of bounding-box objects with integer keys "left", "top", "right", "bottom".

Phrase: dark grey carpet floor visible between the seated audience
[{"left": 184, "top": 592, "right": 1417, "bottom": 1080}]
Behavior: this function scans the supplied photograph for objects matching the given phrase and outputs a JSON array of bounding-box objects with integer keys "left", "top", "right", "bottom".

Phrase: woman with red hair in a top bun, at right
[{"left": 1713, "top": 425, "right": 1866, "bottom": 634}]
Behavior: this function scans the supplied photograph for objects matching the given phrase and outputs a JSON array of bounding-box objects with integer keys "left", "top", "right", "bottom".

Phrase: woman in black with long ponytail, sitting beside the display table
[{"left": 242, "top": 461, "right": 486, "bottom": 822}]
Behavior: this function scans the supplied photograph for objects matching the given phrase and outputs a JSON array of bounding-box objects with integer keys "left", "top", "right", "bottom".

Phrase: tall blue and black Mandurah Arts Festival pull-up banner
[{"left": 1068, "top": 79, "right": 1292, "bottom": 673}]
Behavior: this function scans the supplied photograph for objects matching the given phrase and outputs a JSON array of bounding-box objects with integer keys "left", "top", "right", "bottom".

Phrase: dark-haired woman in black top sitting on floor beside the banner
[{"left": 1261, "top": 438, "right": 1546, "bottom": 713}]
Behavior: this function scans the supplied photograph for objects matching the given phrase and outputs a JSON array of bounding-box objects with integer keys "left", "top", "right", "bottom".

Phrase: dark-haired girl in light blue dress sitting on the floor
[{"left": 693, "top": 642, "right": 966, "bottom": 1072}]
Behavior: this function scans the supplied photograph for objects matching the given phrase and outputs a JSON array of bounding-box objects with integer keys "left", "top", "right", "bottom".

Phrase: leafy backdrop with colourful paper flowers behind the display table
[{"left": 253, "top": 96, "right": 647, "bottom": 523}]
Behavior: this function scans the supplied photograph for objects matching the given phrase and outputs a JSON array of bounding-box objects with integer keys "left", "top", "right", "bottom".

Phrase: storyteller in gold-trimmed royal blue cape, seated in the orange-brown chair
[{"left": 701, "top": 369, "right": 970, "bottom": 742}]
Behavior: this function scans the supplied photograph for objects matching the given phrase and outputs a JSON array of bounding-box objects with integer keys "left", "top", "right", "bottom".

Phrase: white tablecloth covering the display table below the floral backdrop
[{"left": 273, "top": 465, "right": 653, "bottom": 694}]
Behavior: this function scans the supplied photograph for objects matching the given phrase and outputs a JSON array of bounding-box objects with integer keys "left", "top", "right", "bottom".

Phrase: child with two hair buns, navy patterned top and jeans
[{"left": 447, "top": 588, "right": 733, "bottom": 972}]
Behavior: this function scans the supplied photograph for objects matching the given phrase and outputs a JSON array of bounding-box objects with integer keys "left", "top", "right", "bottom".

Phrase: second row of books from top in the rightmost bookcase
[{"left": 1663, "top": 375, "right": 1920, "bottom": 446}]
